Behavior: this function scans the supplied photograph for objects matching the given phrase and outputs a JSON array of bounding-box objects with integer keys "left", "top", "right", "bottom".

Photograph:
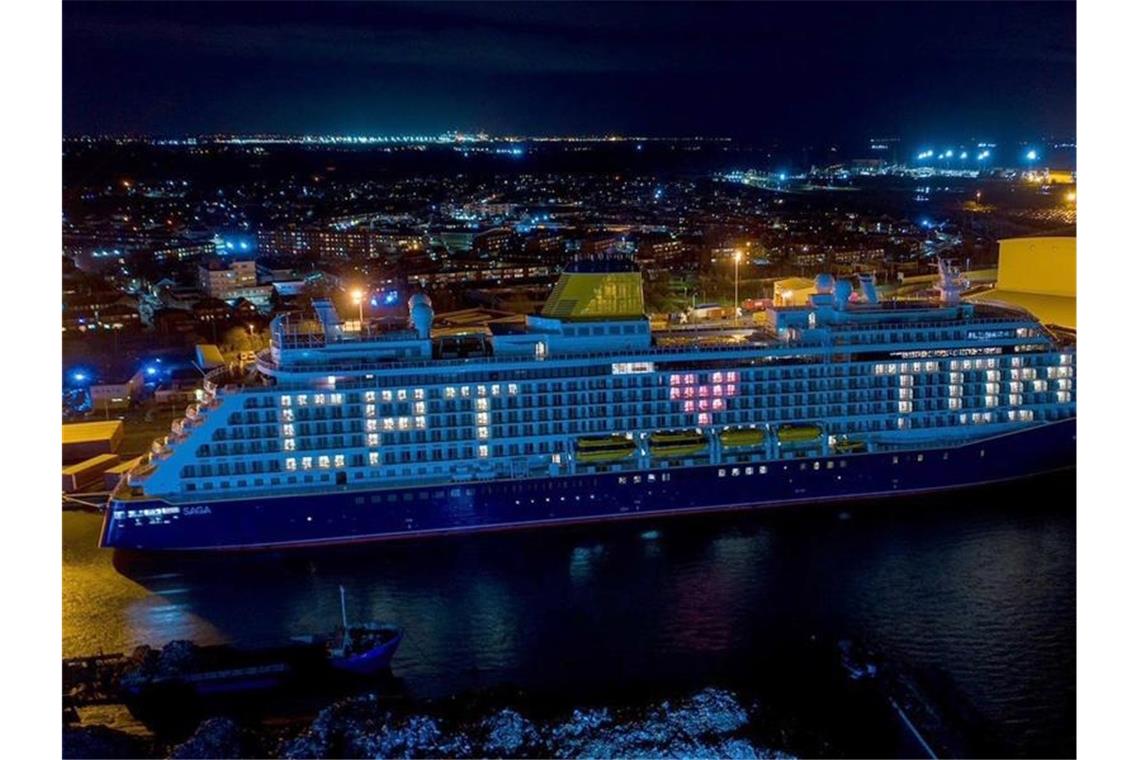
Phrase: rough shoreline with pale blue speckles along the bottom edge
[{"left": 63, "top": 688, "right": 793, "bottom": 759}]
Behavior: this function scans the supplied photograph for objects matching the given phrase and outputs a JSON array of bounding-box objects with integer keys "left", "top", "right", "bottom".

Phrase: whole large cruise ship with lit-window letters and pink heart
[{"left": 101, "top": 259, "right": 1076, "bottom": 550}]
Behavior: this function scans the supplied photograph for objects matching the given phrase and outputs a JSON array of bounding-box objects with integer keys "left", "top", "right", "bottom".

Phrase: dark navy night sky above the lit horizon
[{"left": 63, "top": 2, "right": 1076, "bottom": 140}]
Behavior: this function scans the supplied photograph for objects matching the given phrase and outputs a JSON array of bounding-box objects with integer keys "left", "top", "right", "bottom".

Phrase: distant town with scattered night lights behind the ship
[{"left": 62, "top": 132, "right": 1076, "bottom": 453}]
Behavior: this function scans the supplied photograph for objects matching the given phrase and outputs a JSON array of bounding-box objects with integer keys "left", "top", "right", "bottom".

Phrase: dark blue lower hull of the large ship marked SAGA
[{"left": 101, "top": 418, "right": 1076, "bottom": 550}]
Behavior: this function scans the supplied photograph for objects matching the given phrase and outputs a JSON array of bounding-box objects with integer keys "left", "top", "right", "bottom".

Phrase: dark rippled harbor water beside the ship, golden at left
[{"left": 63, "top": 474, "right": 1076, "bottom": 757}]
